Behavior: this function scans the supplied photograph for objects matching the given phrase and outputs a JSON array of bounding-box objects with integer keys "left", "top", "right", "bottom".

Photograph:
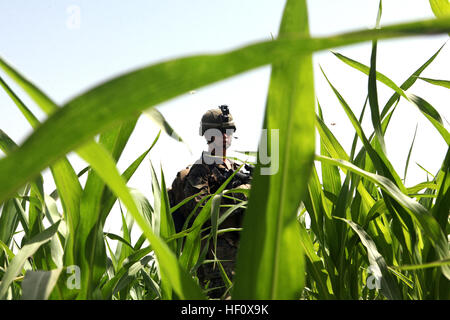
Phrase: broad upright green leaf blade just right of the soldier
[{"left": 232, "top": 1, "right": 315, "bottom": 299}]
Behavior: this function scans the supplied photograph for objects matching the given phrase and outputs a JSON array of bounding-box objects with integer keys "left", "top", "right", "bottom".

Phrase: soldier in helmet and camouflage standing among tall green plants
[{"left": 169, "top": 105, "right": 251, "bottom": 298}]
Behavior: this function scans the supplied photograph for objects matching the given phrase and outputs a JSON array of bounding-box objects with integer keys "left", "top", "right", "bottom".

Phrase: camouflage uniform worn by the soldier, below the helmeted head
[{"left": 169, "top": 153, "right": 250, "bottom": 298}]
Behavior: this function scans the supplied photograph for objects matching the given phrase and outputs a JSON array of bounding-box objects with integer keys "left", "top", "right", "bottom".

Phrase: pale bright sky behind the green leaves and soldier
[{"left": 0, "top": 0, "right": 450, "bottom": 235}]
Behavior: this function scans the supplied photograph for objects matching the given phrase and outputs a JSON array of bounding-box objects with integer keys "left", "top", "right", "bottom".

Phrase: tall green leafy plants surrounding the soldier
[{"left": 0, "top": 1, "right": 450, "bottom": 299}]
